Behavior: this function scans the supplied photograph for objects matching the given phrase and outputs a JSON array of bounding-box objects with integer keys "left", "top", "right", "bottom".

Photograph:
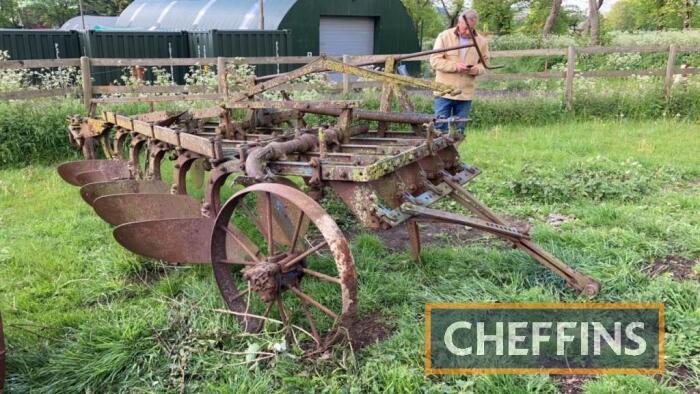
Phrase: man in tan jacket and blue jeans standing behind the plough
[{"left": 430, "top": 10, "right": 489, "bottom": 134}]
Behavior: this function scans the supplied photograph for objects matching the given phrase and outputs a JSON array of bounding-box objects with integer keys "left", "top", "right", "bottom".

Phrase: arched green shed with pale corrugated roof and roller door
[{"left": 116, "top": 0, "right": 419, "bottom": 63}]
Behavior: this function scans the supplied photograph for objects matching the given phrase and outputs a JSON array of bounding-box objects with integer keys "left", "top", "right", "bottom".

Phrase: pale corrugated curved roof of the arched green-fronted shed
[{"left": 116, "top": 0, "right": 296, "bottom": 31}]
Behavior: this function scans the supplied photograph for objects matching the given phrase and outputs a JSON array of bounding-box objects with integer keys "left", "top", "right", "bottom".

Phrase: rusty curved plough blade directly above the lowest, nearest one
[{"left": 92, "top": 194, "right": 202, "bottom": 226}]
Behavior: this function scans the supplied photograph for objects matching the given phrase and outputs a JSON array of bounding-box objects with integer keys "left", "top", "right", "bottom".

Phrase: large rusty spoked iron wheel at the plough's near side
[{"left": 211, "top": 183, "right": 357, "bottom": 347}]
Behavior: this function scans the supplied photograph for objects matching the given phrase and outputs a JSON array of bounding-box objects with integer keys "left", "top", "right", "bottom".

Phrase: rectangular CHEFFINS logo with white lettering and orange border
[{"left": 425, "top": 304, "right": 664, "bottom": 374}]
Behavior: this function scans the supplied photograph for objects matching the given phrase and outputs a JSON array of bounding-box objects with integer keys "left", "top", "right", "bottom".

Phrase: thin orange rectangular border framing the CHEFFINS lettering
[{"left": 424, "top": 303, "right": 666, "bottom": 375}]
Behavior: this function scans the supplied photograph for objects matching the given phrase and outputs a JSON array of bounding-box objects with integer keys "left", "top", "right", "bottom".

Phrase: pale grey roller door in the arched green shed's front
[{"left": 320, "top": 16, "right": 374, "bottom": 56}]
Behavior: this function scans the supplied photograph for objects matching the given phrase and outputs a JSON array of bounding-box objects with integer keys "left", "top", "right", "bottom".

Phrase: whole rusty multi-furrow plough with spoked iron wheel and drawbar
[{"left": 58, "top": 49, "right": 600, "bottom": 347}]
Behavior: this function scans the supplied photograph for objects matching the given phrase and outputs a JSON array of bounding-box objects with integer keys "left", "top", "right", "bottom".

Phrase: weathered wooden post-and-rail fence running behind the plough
[{"left": 0, "top": 45, "right": 700, "bottom": 109}]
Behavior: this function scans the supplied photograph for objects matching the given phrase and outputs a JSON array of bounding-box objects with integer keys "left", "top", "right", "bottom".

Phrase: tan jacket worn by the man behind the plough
[{"left": 430, "top": 28, "right": 489, "bottom": 101}]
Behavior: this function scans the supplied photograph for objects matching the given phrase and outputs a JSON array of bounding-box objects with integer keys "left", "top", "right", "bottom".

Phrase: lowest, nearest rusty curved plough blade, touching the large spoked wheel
[{"left": 114, "top": 218, "right": 258, "bottom": 264}]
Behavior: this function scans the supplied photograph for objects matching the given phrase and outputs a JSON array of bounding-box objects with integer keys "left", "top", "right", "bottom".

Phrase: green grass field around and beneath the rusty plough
[{"left": 0, "top": 121, "right": 700, "bottom": 393}]
